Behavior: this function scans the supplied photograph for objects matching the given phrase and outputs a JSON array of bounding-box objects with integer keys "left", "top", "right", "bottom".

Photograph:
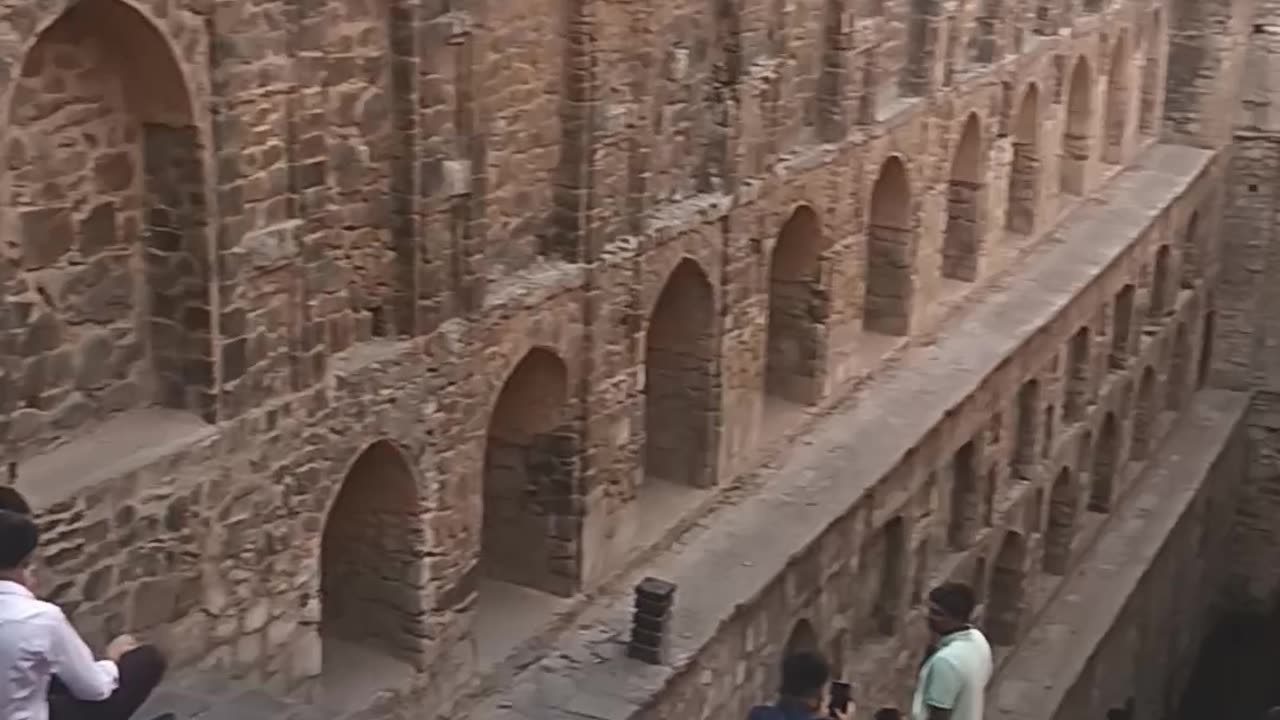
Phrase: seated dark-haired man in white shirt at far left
[{"left": 0, "top": 502, "right": 172, "bottom": 720}]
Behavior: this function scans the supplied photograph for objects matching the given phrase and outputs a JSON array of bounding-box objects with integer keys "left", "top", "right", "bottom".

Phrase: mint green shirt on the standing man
[{"left": 911, "top": 628, "right": 991, "bottom": 720}]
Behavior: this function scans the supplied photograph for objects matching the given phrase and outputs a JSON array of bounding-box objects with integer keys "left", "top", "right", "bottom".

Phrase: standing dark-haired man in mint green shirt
[{"left": 911, "top": 583, "right": 991, "bottom": 720}]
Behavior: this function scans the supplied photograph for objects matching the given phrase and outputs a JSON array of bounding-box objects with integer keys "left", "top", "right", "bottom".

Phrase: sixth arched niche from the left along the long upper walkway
[{"left": 942, "top": 113, "right": 986, "bottom": 282}]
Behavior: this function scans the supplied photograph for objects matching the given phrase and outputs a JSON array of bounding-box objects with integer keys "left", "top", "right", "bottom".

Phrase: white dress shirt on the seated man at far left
[{"left": 0, "top": 580, "right": 120, "bottom": 720}]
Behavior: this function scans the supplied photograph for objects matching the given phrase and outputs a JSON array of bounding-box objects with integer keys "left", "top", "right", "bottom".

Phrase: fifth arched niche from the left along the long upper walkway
[{"left": 863, "top": 156, "right": 915, "bottom": 336}]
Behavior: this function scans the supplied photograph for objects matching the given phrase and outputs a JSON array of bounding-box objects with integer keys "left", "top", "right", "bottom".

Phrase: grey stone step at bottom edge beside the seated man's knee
[{"left": 134, "top": 674, "right": 325, "bottom": 720}]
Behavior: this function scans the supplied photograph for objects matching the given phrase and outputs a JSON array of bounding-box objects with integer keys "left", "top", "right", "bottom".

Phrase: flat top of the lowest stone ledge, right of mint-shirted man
[{"left": 988, "top": 391, "right": 1249, "bottom": 720}]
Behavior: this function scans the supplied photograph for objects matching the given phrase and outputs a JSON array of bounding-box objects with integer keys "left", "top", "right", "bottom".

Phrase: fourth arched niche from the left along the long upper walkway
[{"left": 764, "top": 205, "right": 828, "bottom": 405}]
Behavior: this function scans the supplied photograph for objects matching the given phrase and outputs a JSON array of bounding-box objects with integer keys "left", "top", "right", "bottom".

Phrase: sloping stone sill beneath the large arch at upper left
[{"left": 17, "top": 407, "right": 218, "bottom": 510}]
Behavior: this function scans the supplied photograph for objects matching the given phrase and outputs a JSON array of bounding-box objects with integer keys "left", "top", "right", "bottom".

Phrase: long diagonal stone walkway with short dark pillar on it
[{"left": 477, "top": 145, "right": 1213, "bottom": 720}]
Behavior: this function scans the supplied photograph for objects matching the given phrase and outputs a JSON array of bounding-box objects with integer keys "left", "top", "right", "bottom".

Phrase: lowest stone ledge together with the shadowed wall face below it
[{"left": 988, "top": 391, "right": 1249, "bottom": 720}]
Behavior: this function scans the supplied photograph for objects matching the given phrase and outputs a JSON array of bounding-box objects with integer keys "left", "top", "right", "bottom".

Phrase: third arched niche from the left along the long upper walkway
[{"left": 644, "top": 259, "right": 718, "bottom": 487}]
